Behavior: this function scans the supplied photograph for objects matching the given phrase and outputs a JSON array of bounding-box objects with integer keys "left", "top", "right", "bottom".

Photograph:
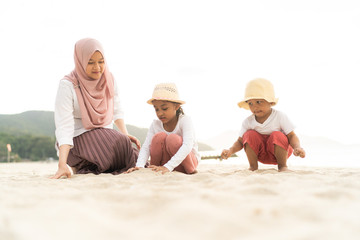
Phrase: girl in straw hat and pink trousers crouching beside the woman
[{"left": 127, "top": 83, "right": 200, "bottom": 174}]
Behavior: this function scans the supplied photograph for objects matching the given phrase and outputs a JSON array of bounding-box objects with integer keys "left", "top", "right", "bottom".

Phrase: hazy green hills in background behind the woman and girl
[{"left": 0, "top": 111, "right": 212, "bottom": 161}]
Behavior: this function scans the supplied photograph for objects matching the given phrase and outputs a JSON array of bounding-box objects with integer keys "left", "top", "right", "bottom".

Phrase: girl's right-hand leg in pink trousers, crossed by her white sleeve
[{"left": 166, "top": 134, "right": 198, "bottom": 174}]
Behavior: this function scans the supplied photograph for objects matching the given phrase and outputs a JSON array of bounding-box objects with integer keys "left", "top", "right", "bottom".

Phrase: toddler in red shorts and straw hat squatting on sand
[{"left": 221, "top": 78, "right": 305, "bottom": 172}]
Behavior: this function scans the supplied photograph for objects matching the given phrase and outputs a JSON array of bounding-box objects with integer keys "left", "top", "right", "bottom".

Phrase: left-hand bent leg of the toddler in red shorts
[{"left": 243, "top": 130, "right": 264, "bottom": 171}]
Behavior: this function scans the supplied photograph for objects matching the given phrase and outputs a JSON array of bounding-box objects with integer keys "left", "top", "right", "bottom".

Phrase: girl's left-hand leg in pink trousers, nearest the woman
[{"left": 150, "top": 132, "right": 171, "bottom": 166}]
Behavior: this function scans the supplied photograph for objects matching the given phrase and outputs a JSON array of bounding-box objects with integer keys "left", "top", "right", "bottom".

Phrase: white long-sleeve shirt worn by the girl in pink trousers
[{"left": 136, "top": 115, "right": 200, "bottom": 171}]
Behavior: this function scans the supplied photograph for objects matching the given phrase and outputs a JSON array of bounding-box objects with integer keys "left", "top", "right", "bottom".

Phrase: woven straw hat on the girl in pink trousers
[{"left": 147, "top": 83, "right": 185, "bottom": 104}]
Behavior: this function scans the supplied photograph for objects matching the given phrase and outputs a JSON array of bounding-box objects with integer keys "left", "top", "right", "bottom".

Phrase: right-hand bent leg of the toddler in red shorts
[{"left": 267, "top": 131, "right": 293, "bottom": 172}]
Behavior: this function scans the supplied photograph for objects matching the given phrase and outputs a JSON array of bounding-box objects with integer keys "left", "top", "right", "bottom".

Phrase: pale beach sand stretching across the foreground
[{"left": 0, "top": 161, "right": 360, "bottom": 240}]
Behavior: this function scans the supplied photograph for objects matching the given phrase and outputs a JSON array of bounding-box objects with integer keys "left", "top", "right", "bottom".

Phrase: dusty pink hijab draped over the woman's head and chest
[{"left": 65, "top": 38, "right": 114, "bottom": 129}]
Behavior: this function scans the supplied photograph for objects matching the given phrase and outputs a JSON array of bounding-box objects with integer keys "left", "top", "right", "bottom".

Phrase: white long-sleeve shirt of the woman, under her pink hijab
[{"left": 55, "top": 79, "right": 124, "bottom": 146}]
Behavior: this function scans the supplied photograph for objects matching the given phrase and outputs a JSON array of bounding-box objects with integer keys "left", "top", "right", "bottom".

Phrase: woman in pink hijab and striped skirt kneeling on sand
[{"left": 52, "top": 38, "right": 140, "bottom": 179}]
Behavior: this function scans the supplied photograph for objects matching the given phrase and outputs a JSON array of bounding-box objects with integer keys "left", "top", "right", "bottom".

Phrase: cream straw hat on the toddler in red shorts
[{"left": 238, "top": 78, "right": 279, "bottom": 110}]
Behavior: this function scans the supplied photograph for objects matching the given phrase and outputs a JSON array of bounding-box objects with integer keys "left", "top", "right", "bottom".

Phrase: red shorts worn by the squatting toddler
[{"left": 243, "top": 130, "right": 293, "bottom": 165}]
